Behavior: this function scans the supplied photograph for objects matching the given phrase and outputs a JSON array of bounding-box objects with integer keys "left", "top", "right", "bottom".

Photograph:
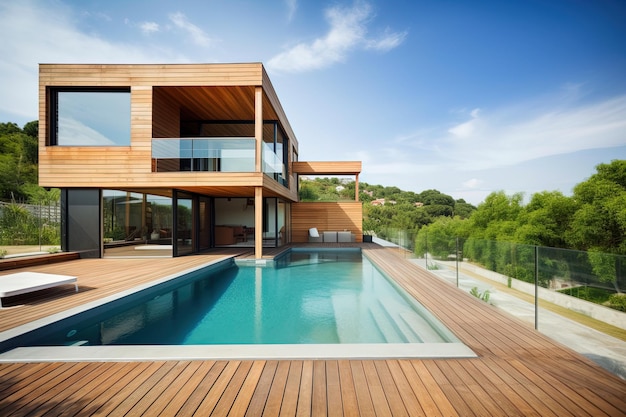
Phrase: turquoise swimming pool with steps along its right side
[{"left": 0, "top": 249, "right": 473, "bottom": 360}]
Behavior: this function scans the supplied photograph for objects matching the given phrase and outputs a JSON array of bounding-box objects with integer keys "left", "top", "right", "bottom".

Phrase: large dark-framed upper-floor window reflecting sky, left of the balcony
[{"left": 50, "top": 88, "right": 130, "bottom": 146}]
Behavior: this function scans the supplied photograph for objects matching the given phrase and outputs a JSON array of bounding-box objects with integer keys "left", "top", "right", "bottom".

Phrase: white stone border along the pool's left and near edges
[{"left": 0, "top": 250, "right": 477, "bottom": 363}]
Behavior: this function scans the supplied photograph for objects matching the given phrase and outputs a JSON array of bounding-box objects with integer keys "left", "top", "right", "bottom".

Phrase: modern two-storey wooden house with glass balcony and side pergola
[{"left": 39, "top": 63, "right": 362, "bottom": 258}]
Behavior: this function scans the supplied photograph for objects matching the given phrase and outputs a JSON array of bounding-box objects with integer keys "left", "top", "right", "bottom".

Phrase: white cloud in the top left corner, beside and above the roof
[{"left": 0, "top": 0, "right": 186, "bottom": 122}]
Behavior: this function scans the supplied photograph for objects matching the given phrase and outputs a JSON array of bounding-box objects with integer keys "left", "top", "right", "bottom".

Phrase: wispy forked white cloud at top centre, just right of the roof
[{"left": 267, "top": 2, "right": 406, "bottom": 72}]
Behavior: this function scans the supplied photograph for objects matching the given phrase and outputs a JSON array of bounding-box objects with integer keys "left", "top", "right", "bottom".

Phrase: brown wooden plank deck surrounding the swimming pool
[{"left": 0, "top": 244, "right": 626, "bottom": 416}]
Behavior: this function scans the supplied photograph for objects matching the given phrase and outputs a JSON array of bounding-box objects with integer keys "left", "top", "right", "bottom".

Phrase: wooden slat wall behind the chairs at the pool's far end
[{"left": 291, "top": 201, "right": 363, "bottom": 243}]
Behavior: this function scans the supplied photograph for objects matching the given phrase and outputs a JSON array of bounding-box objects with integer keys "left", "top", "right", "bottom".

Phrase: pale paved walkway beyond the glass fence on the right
[{"left": 412, "top": 255, "right": 626, "bottom": 379}]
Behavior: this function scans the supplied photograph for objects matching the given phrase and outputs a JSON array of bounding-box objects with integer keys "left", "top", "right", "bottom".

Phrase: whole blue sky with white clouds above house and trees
[{"left": 0, "top": 0, "right": 626, "bottom": 204}]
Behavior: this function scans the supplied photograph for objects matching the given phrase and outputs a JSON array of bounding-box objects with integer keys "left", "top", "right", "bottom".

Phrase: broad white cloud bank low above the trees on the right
[{"left": 352, "top": 93, "right": 626, "bottom": 204}]
